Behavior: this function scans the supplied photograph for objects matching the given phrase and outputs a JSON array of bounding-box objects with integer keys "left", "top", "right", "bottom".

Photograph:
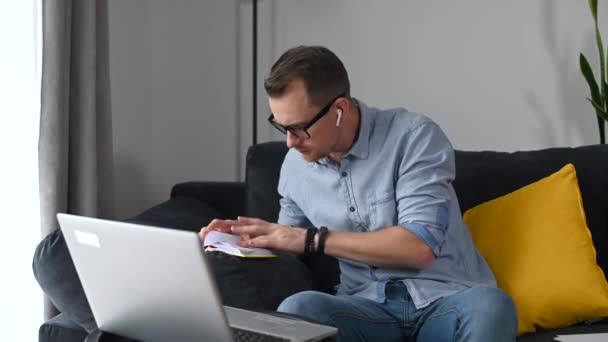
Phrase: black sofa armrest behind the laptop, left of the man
[{"left": 171, "top": 182, "right": 247, "bottom": 218}]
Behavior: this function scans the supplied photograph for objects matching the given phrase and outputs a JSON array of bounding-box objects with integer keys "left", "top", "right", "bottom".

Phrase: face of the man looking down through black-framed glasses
[{"left": 268, "top": 79, "right": 338, "bottom": 162}]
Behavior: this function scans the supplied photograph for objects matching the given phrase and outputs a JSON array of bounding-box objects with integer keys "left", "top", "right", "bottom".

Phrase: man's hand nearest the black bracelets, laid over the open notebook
[{"left": 231, "top": 217, "right": 306, "bottom": 254}]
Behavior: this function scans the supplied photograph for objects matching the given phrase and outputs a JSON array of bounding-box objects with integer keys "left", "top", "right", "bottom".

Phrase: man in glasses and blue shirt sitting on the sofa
[{"left": 200, "top": 46, "right": 517, "bottom": 342}]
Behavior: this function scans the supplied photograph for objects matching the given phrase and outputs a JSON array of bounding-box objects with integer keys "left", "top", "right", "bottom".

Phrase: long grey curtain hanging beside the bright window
[{"left": 38, "top": 0, "right": 113, "bottom": 318}]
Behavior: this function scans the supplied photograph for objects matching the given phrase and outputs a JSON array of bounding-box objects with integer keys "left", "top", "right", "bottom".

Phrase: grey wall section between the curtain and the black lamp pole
[{"left": 109, "top": 0, "right": 240, "bottom": 218}]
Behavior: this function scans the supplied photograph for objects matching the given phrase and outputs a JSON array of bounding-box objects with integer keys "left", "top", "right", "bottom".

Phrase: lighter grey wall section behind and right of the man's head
[{"left": 266, "top": 0, "right": 608, "bottom": 150}]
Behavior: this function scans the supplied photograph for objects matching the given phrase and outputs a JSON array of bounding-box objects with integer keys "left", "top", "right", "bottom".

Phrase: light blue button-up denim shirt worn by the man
[{"left": 278, "top": 100, "right": 496, "bottom": 308}]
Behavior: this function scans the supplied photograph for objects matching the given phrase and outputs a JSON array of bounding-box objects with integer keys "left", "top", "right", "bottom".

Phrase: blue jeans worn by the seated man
[{"left": 278, "top": 282, "right": 517, "bottom": 342}]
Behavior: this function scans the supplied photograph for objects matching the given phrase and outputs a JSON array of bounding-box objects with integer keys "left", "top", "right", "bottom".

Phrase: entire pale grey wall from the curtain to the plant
[{"left": 110, "top": 0, "right": 608, "bottom": 217}]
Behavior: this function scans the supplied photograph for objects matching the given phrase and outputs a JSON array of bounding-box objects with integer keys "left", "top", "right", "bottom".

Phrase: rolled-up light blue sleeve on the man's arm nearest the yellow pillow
[{"left": 396, "top": 122, "right": 455, "bottom": 256}]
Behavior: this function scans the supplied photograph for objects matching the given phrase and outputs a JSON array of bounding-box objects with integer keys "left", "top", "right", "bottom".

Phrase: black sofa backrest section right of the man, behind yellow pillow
[{"left": 454, "top": 145, "right": 608, "bottom": 274}]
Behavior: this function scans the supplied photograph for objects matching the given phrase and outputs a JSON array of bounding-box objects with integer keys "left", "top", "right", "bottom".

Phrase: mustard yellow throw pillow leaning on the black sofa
[{"left": 464, "top": 164, "right": 608, "bottom": 335}]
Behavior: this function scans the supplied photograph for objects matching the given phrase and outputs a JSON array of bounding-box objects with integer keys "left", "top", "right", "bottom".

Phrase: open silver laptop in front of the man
[{"left": 57, "top": 214, "right": 337, "bottom": 342}]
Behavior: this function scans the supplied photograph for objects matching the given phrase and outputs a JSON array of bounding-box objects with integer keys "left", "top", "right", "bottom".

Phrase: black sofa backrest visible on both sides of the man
[{"left": 245, "top": 142, "right": 608, "bottom": 274}]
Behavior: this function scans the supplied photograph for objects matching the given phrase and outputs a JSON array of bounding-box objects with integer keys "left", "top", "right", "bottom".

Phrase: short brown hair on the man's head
[{"left": 264, "top": 46, "right": 350, "bottom": 106}]
